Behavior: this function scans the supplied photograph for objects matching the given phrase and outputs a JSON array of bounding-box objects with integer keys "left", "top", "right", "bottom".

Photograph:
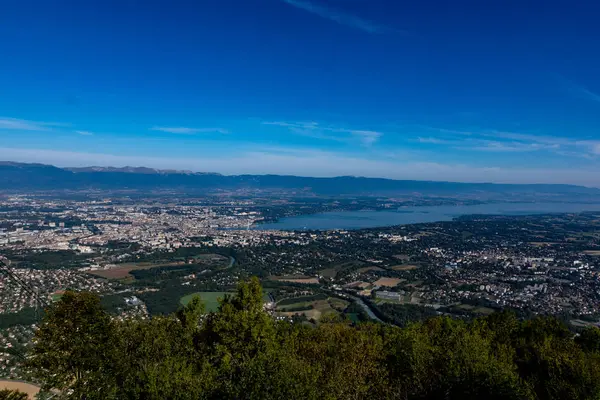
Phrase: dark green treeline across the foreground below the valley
[{"left": 28, "top": 279, "right": 600, "bottom": 400}]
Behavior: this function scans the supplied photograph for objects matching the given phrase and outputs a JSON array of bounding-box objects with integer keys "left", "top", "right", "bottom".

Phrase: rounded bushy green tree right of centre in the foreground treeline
[{"left": 388, "top": 317, "right": 528, "bottom": 399}]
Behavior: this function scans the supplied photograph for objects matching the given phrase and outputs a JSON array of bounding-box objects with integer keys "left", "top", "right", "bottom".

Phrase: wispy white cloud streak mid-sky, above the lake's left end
[{"left": 262, "top": 121, "right": 383, "bottom": 146}]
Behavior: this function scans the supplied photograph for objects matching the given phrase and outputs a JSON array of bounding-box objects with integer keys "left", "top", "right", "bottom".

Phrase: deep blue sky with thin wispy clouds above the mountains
[{"left": 0, "top": 0, "right": 600, "bottom": 186}]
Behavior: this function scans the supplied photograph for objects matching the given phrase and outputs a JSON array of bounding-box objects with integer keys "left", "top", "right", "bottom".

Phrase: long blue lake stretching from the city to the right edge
[{"left": 254, "top": 203, "right": 600, "bottom": 230}]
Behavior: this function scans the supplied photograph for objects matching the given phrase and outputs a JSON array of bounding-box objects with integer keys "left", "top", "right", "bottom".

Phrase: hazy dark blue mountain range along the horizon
[{"left": 0, "top": 162, "right": 600, "bottom": 200}]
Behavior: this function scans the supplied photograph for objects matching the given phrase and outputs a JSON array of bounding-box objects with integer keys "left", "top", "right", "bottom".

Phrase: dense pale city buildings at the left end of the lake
[{"left": 0, "top": 197, "right": 318, "bottom": 254}]
